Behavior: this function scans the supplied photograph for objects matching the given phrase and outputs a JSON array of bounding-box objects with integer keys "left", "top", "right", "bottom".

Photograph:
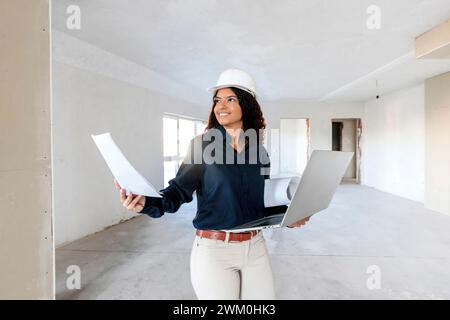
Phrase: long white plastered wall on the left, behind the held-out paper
[{"left": 53, "top": 35, "right": 210, "bottom": 245}]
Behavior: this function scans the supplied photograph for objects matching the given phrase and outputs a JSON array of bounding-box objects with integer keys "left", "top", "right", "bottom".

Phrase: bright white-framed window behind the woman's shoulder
[{"left": 163, "top": 115, "right": 206, "bottom": 187}]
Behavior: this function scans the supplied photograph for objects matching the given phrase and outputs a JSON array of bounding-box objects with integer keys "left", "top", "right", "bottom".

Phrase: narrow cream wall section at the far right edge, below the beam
[{"left": 425, "top": 72, "right": 450, "bottom": 214}]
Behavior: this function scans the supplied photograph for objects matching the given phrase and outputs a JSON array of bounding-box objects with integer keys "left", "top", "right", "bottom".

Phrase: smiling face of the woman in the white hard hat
[{"left": 214, "top": 88, "right": 242, "bottom": 129}]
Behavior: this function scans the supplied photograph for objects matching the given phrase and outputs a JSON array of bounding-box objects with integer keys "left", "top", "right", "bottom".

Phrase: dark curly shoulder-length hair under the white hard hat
[{"left": 206, "top": 87, "right": 266, "bottom": 141}]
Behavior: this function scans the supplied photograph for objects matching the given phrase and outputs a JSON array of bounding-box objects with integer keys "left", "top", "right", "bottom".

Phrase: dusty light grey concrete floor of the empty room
[{"left": 56, "top": 185, "right": 450, "bottom": 299}]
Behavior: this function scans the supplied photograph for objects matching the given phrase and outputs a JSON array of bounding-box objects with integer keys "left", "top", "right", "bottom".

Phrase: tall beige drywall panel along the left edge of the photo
[{"left": 0, "top": 0, "right": 54, "bottom": 299}]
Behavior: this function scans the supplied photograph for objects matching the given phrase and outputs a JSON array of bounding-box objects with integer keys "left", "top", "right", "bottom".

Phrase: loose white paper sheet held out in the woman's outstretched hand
[{"left": 91, "top": 132, "right": 161, "bottom": 198}]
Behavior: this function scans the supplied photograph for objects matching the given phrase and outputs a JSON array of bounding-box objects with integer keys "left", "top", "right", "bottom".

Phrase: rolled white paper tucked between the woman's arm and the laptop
[{"left": 264, "top": 177, "right": 300, "bottom": 208}]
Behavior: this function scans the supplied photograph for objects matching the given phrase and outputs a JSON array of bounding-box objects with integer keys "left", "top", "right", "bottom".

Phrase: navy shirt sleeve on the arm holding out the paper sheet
[{"left": 140, "top": 139, "right": 204, "bottom": 218}]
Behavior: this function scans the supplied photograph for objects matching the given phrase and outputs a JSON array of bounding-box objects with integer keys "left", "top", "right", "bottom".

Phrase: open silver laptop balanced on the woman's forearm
[{"left": 227, "top": 150, "right": 353, "bottom": 232}]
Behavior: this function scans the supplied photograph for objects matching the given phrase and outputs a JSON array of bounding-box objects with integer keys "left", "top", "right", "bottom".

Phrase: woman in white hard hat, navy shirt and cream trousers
[{"left": 116, "top": 69, "right": 308, "bottom": 299}]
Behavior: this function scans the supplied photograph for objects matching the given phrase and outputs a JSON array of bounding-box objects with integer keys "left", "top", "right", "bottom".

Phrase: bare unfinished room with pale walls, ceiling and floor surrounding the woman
[{"left": 0, "top": 0, "right": 450, "bottom": 300}]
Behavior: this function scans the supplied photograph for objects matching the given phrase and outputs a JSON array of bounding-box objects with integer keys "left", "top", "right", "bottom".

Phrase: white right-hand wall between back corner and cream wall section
[{"left": 362, "top": 83, "right": 425, "bottom": 202}]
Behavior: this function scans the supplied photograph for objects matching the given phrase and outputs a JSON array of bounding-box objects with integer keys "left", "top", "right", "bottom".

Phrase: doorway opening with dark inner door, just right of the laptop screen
[{"left": 332, "top": 119, "right": 362, "bottom": 184}]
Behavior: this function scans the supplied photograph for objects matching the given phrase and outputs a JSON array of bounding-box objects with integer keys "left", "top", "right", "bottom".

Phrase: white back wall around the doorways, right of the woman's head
[{"left": 261, "top": 101, "right": 364, "bottom": 175}]
